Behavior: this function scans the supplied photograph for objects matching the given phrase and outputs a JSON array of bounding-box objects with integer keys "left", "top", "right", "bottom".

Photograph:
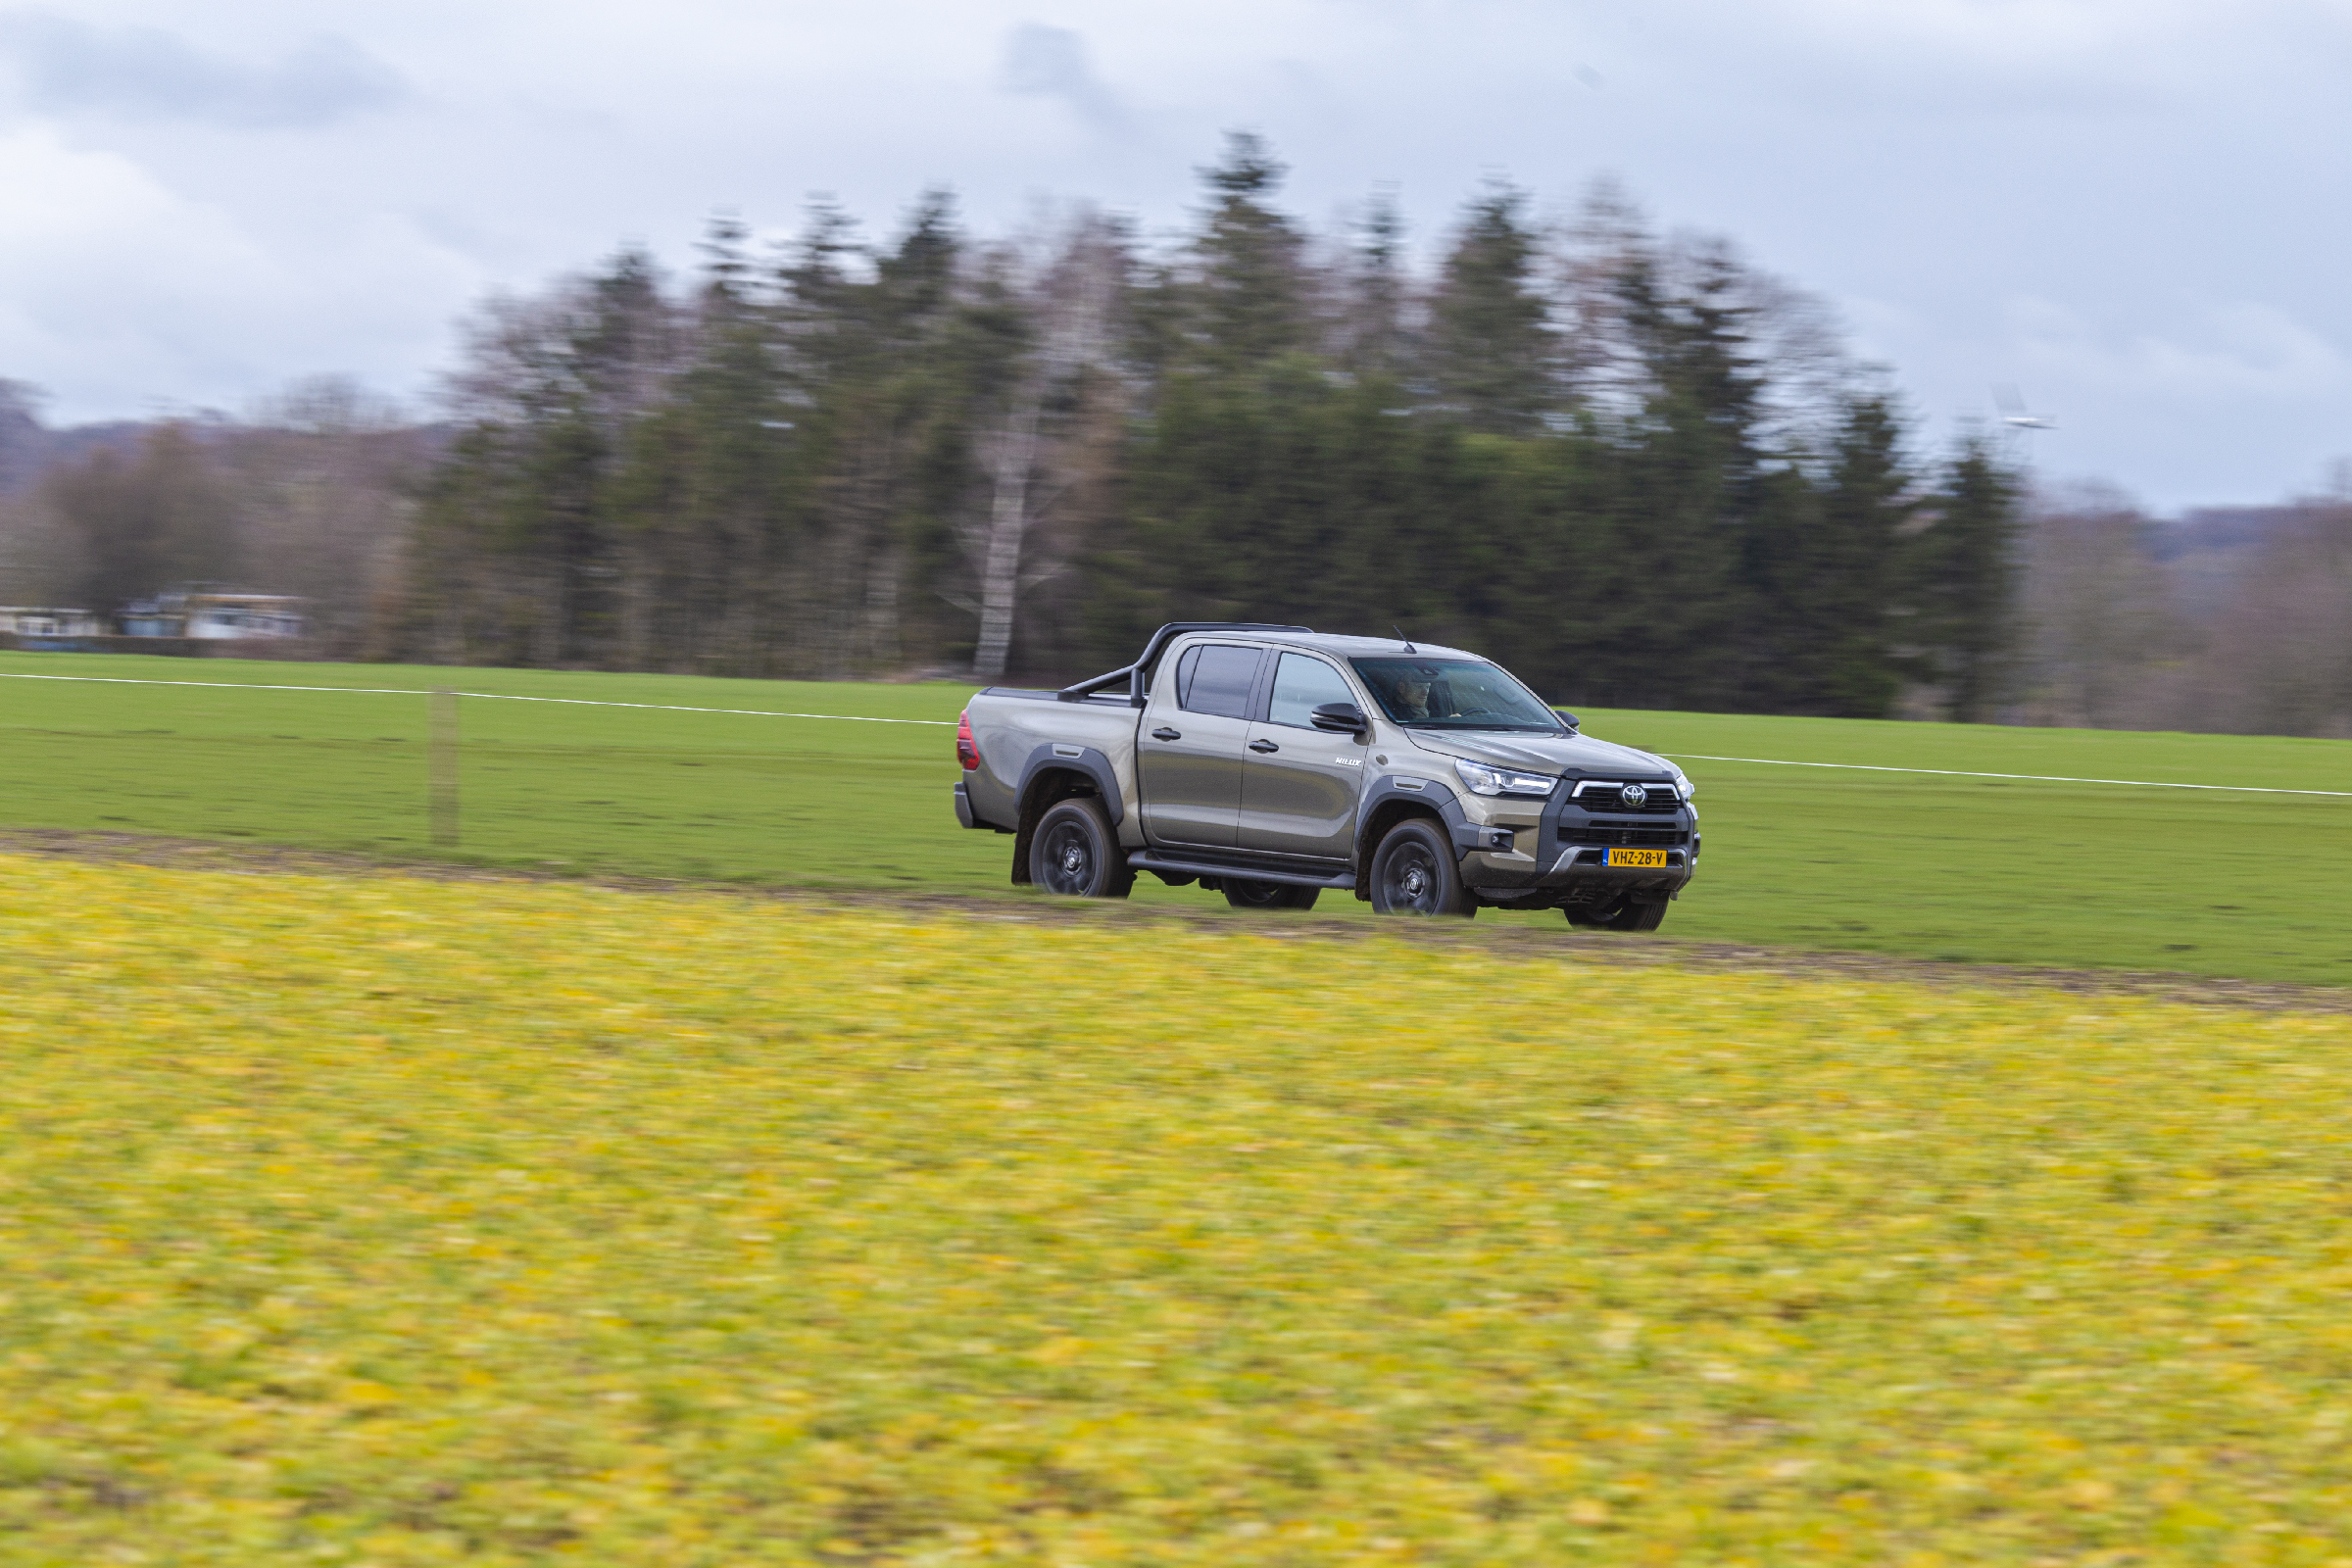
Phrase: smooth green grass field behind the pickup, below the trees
[{"left": 0, "top": 654, "right": 2352, "bottom": 985}]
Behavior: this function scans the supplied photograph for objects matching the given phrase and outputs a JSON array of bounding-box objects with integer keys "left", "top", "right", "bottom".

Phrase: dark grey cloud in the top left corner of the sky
[{"left": 0, "top": 10, "right": 410, "bottom": 129}]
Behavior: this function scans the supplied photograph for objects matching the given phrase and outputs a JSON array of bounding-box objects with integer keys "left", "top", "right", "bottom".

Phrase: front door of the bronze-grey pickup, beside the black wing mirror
[{"left": 1240, "top": 654, "right": 1366, "bottom": 860}]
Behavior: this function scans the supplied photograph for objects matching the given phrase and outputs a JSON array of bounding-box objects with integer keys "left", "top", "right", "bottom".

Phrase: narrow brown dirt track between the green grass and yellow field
[{"left": 0, "top": 827, "right": 2352, "bottom": 1013}]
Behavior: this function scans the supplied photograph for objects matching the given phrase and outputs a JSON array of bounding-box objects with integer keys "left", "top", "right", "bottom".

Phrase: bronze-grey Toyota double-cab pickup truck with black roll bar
[{"left": 955, "top": 620, "right": 1698, "bottom": 931}]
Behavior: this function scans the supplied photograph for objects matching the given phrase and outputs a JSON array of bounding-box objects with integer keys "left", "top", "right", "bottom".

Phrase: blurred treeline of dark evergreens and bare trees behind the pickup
[{"left": 0, "top": 136, "right": 2352, "bottom": 733}]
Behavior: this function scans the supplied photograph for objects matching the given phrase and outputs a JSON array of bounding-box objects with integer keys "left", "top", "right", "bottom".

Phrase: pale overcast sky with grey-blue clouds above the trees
[{"left": 0, "top": 0, "right": 2352, "bottom": 511}]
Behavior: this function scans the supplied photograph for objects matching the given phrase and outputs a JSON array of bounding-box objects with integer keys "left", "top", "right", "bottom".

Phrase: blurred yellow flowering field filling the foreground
[{"left": 0, "top": 858, "right": 2352, "bottom": 1568}]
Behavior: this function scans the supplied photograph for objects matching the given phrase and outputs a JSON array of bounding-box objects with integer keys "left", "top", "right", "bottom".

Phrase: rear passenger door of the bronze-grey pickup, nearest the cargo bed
[{"left": 1136, "top": 642, "right": 1263, "bottom": 849}]
